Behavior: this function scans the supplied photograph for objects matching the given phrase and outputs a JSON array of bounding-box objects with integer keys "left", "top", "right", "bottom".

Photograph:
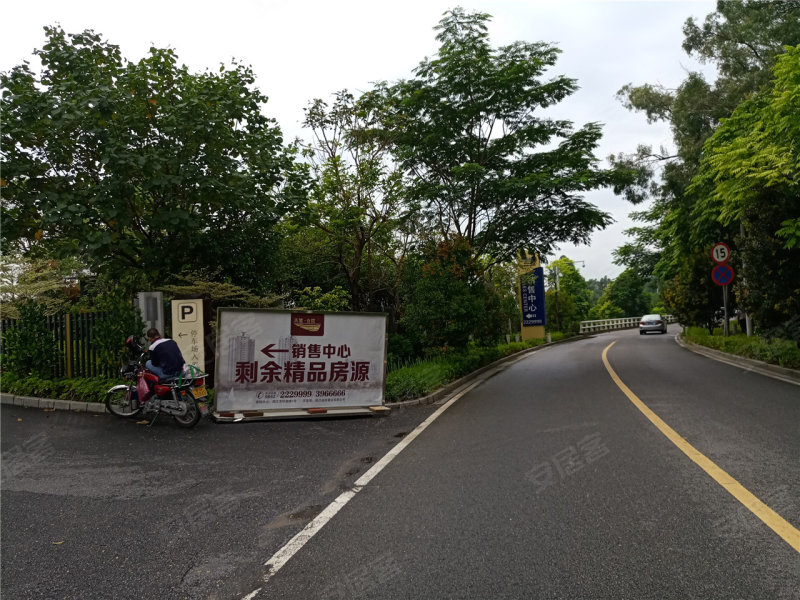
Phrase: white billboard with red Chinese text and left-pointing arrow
[{"left": 215, "top": 308, "right": 386, "bottom": 412}]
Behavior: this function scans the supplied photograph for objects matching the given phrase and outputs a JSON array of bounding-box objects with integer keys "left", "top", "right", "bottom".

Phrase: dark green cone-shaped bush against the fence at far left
[{"left": 3, "top": 300, "right": 60, "bottom": 377}]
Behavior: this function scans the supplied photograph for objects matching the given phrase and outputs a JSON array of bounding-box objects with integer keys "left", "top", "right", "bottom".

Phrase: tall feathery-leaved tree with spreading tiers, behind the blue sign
[{"left": 375, "top": 8, "right": 631, "bottom": 263}]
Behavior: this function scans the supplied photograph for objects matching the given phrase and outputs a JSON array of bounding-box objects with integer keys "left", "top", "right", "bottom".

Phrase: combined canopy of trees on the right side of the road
[{"left": 615, "top": 0, "right": 800, "bottom": 328}]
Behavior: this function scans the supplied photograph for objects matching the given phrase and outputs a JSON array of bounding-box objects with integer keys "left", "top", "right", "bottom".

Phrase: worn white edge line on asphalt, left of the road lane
[{"left": 242, "top": 378, "right": 485, "bottom": 600}]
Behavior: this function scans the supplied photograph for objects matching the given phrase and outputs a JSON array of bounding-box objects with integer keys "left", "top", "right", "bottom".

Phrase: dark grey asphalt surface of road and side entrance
[{"left": 2, "top": 332, "right": 800, "bottom": 600}]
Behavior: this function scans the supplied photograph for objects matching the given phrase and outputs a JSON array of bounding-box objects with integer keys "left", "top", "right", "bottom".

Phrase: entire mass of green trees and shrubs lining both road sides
[{"left": 0, "top": 0, "right": 800, "bottom": 400}]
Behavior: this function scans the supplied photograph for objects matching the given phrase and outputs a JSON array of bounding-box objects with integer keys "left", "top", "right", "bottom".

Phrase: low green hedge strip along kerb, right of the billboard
[{"left": 386, "top": 332, "right": 568, "bottom": 402}]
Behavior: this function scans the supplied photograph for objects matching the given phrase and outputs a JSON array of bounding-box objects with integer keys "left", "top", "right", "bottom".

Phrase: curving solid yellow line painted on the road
[{"left": 603, "top": 342, "right": 800, "bottom": 553}]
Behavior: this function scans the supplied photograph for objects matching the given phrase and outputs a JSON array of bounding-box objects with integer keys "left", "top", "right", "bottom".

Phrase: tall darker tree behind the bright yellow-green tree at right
[{"left": 615, "top": 0, "right": 800, "bottom": 286}]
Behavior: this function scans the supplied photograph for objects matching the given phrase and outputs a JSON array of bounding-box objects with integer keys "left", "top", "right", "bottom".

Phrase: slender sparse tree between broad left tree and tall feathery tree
[{"left": 301, "top": 91, "right": 404, "bottom": 311}]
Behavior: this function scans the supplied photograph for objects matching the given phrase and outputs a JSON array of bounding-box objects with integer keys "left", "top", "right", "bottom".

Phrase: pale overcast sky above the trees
[{"left": 0, "top": 0, "right": 716, "bottom": 279}]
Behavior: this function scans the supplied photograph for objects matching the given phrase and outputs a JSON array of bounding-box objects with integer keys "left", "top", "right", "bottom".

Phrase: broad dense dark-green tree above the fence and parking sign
[{"left": 0, "top": 27, "right": 303, "bottom": 287}]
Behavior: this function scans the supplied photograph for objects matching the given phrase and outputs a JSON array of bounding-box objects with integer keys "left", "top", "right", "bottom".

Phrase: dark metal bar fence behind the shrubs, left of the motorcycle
[{"left": 0, "top": 313, "right": 119, "bottom": 379}]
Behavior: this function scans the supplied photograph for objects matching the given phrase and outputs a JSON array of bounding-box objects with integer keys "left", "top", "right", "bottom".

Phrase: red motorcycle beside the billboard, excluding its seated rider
[{"left": 106, "top": 336, "right": 209, "bottom": 428}]
